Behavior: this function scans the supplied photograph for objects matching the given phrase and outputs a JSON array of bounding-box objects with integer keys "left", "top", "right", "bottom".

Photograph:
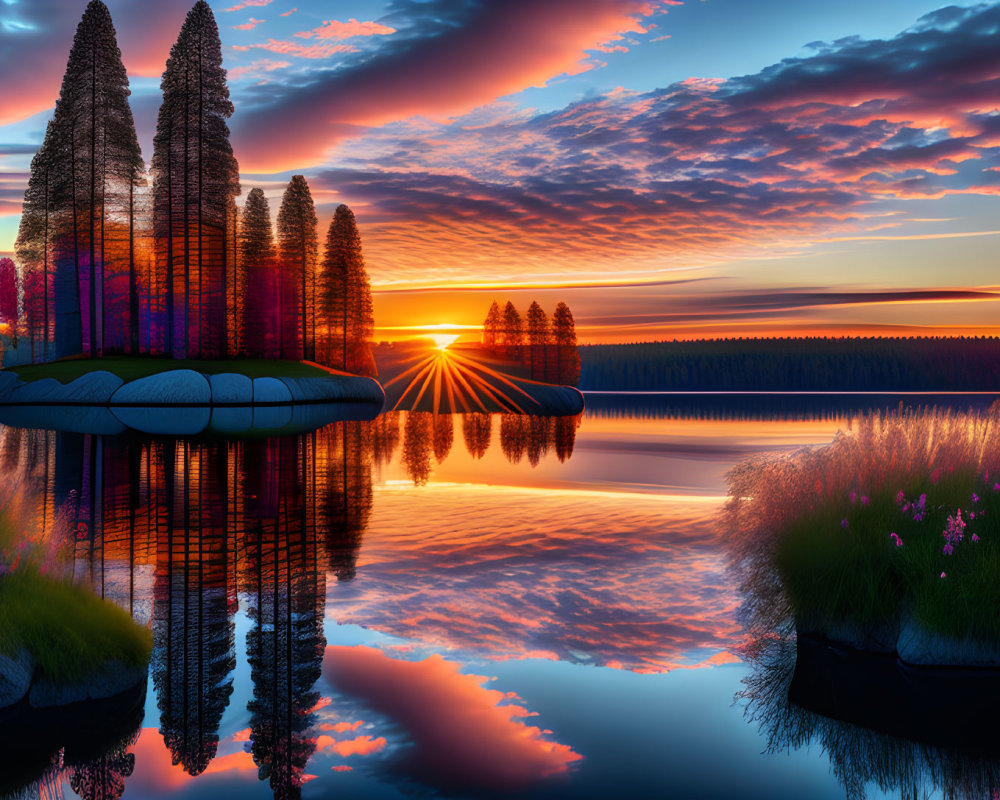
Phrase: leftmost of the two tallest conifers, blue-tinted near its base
[{"left": 18, "top": 0, "right": 144, "bottom": 357}]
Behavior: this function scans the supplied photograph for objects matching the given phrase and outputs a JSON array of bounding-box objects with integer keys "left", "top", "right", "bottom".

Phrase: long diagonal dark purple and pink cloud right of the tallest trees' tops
[{"left": 234, "top": 0, "right": 672, "bottom": 171}]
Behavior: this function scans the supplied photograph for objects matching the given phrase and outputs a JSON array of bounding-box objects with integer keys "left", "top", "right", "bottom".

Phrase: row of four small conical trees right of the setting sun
[{"left": 482, "top": 300, "right": 580, "bottom": 386}]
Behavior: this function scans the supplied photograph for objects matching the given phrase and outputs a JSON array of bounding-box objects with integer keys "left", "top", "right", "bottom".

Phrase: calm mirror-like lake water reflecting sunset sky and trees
[{"left": 0, "top": 397, "right": 997, "bottom": 800}]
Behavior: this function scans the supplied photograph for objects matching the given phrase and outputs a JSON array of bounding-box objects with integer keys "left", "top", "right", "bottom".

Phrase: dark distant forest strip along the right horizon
[{"left": 579, "top": 337, "right": 1000, "bottom": 392}]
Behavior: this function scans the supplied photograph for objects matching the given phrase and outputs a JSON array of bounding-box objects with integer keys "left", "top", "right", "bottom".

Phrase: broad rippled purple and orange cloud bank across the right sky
[{"left": 282, "top": 6, "right": 1000, "bottom": 283}]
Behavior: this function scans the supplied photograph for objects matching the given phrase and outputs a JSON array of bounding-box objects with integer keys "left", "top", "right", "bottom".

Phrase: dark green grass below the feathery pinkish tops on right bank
[{"left": 775, "top": 473, "right": 1000, "bottom": 639}]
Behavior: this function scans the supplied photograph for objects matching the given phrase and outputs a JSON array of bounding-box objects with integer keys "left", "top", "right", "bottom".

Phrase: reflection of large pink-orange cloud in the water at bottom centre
[{"left": 323, "top": 646, "right": 581, "bottom": 791}]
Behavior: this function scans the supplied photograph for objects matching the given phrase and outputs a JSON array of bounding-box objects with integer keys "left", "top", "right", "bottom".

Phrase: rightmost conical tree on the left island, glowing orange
[{"left": 321, "top": 205, "right": 375, "bottom": 374}]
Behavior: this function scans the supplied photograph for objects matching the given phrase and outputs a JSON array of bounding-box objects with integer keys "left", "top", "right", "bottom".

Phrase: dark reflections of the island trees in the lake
[{"left": 0, "top": 412, "right": 579, "bottom": 798}]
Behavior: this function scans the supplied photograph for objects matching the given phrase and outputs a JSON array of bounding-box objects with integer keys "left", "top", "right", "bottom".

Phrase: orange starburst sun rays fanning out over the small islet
[{"left": 385, "top": 348, "right": 541, "bottom": 414}]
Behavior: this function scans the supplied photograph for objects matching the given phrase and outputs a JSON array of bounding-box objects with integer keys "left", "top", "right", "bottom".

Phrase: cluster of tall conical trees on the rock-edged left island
[{"left": 12, "top": 0, "right": 373, "bottom": 372}]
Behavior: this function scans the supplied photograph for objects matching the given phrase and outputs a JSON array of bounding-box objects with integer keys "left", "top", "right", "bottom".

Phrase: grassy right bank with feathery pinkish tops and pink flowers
[{"left": 728, "top": 410, "right": 1000, "bottom": 642}]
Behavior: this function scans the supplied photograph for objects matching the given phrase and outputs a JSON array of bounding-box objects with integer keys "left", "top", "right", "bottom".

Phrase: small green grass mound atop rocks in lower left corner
[{"left": 0, "top": 567, "right": 152, "bottom": 683}]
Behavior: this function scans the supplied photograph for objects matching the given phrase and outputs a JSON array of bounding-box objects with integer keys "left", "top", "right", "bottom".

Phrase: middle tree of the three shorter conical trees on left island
[{"left": 278, "top": 175, "right": 317, "bottom": 361}]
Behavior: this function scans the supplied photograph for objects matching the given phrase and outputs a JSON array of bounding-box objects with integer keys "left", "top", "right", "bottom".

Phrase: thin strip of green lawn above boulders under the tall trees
[{"left": 8, "top": 356, "right": 330, "bottom": 383}]
